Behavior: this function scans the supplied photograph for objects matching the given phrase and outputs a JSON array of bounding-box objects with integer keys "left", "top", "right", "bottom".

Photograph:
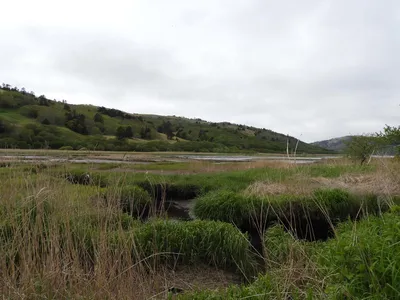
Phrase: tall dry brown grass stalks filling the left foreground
[{"left": 0, "top": 172, "right": 250, "bottom": 299}]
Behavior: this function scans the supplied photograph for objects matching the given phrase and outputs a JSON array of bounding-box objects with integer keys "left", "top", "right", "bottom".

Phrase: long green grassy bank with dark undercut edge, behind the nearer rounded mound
[{"left": 193, "top": 189, "right": 389, "bottom": 240}]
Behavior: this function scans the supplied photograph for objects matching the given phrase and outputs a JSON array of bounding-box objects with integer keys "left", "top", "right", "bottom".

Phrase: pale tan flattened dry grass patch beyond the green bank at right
[{"left": 244, "top": 158, "right": 400, "bottom": 197}]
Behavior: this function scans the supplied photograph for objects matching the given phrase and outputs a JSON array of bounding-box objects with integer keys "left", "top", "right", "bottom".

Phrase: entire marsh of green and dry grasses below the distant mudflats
[{"left": 0, "top": 151, "right": 400, "bottom": 299}]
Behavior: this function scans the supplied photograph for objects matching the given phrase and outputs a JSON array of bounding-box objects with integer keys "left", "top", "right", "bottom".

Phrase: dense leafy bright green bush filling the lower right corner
[{"left": 316, "top": 212, "right": 400, "bottom": 299}]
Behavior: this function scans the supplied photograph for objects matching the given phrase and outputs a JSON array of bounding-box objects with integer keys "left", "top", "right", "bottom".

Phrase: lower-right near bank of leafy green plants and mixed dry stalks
[{"left": 178, "top": 207, "right": 400, "bottom": 300}]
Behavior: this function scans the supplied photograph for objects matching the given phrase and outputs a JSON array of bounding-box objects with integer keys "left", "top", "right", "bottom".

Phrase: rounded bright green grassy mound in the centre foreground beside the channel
[{"left": 110, "top": 220, "right": 253, "bottom": 274}]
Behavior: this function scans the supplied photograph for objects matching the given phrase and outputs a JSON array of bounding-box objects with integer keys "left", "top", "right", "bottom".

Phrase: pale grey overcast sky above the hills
[{"left": 0, "top": 0, "right": 400, "bottom": 142}]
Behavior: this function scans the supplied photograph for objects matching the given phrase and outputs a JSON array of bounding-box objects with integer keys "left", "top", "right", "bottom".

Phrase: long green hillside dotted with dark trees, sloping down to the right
[{"left": 0, "top": 84, "right": 329, "bottom": 153}]
